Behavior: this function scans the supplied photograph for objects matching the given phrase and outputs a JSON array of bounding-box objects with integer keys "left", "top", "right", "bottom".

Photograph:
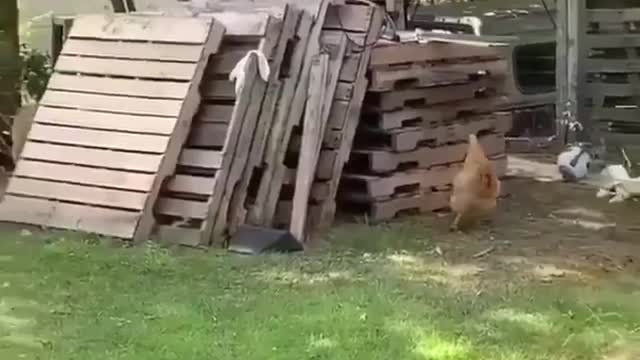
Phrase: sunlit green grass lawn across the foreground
[{"left": 0, "top": 225, "right": 640, "bottom": 360}]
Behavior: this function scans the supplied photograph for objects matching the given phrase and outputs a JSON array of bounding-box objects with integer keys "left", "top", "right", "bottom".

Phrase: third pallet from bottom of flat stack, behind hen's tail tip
[{"left": 345, "top": 133, "right": 505, "bottom": 174}]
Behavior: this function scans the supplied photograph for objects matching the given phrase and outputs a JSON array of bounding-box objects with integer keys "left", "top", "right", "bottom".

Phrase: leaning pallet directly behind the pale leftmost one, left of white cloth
[{"left": 156, "top": 12, "right": 283, "bottom": 246}]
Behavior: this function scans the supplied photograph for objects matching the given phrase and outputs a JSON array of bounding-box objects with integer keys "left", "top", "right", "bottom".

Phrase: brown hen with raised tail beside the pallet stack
[{"left": 450, "top": 134, "right": 500, "bottom": 231}]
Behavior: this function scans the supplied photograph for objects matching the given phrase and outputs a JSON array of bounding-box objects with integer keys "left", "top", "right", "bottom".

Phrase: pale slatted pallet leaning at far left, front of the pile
[{"left": 0, "top": 15, "right": 224, "bottom": 240}]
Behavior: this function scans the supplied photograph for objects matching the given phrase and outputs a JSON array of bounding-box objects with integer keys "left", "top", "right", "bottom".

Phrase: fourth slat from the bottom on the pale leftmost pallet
[{"left": 21, "top": 141, "right": 162, "bottom": 173}]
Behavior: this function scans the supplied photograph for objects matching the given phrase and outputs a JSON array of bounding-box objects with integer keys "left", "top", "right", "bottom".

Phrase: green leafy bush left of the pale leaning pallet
[{"left": 20, "top": 44, "right": 52, "bottom": 102}]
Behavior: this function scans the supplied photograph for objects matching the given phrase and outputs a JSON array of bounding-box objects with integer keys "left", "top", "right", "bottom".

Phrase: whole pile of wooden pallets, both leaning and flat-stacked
[{"left": 0, "top": 0, "right": 511, "bottom": 246}]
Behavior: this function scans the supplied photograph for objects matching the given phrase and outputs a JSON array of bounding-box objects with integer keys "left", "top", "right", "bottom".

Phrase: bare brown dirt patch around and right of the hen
[{"left": 434, "top": 157, "right": 640, "bottom": 281}]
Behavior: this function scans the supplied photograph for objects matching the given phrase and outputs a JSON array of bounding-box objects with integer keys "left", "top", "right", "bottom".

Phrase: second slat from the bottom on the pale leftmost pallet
[{"left": 7, "top": 177, "right": 146, "bottom": 210}]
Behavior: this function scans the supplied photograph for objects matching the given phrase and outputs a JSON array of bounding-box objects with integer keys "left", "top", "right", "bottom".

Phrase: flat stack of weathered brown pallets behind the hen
[{"left": 338, "top": 35, "right": 511, "bottom": 220}]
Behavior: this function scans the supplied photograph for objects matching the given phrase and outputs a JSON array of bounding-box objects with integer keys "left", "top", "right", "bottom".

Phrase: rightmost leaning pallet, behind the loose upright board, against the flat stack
[{"left": 277, "top": 3, "right": 383, "bottom": 235}]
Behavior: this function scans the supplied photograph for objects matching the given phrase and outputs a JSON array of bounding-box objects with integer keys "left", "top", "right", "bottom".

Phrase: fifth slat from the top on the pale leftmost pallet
[{"left": 40, "top": 90, "right": 182, "bottom": 118}]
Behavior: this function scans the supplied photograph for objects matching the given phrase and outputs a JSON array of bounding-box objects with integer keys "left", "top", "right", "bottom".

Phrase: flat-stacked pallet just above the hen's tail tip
[{"left": 355, "top": 112, "right": 512, "bottom": 152}]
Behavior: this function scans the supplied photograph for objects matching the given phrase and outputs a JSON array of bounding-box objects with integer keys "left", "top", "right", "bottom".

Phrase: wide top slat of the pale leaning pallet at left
[{"left": 69, "top": 14, "right": 213, "bottom": 45}]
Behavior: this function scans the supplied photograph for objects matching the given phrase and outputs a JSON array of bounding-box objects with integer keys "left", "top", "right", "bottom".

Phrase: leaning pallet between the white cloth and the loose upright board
[{"left": 186, "top": 0, "right": 330, "bottom": 239}]
